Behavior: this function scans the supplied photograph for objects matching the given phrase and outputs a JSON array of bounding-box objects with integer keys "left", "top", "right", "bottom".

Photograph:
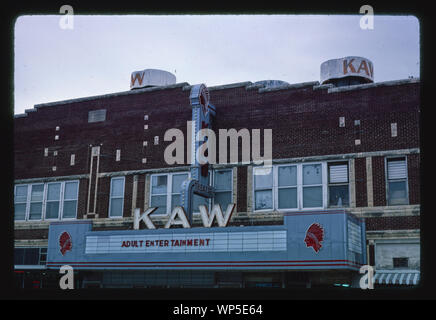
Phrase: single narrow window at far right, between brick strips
[{"left": 386, "top": 158, "right": 409, "bottom": 205}]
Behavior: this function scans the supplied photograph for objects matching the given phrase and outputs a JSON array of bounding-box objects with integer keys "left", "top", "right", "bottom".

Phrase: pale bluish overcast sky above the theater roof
[{"left": 14, "top": 14, "right": 420, "bottom": 114}]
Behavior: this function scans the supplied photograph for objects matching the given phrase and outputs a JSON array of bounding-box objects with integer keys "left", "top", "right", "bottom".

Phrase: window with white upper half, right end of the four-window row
[{"left": 328, "top": 162, "right": 350, "bottom": 207}]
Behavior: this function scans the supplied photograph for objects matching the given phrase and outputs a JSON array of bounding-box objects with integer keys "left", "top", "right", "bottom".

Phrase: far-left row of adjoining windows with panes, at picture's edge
[{"left": 14, "top": 181, "right": 79, "bottom": 220}]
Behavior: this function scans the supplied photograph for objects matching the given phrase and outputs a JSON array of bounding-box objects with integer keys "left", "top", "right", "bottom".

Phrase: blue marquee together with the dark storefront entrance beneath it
[{"left": 47, "top": 210, "right": 366, "bottom": 287}]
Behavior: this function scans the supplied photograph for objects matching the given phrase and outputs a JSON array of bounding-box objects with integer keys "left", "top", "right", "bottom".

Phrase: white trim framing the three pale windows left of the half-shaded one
[{"left": 251, "top": 161, "right": 328, "bottom": 213}]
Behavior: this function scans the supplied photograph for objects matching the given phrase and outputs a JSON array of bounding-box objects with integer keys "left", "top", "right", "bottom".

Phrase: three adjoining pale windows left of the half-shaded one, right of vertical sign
[{"left": 253, "top": 163, "right": 327, "bottom": 211}]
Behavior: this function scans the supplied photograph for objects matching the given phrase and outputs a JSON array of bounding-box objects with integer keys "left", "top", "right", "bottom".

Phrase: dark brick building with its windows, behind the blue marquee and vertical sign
[{"left": 14, "top": 57, "right": 420, "bottom": 287}]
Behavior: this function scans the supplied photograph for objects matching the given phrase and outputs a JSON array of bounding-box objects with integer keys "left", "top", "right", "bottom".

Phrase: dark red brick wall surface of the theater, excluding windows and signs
[{"left": 14, "top": 81, "right": 420, "bottom": 239}]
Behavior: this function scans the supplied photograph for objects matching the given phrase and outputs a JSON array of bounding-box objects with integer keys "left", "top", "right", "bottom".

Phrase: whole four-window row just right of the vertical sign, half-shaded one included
[{"left": 253, "top": 162, "right": 349, "bottom": 211}]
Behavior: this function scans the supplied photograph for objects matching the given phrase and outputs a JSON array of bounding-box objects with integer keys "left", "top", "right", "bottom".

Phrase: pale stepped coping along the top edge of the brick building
[{"left": 14, "top": 78, "right": 420, "bottom": 118}]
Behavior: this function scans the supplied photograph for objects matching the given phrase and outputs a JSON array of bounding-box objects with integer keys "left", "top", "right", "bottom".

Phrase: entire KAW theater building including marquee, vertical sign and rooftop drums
[{"left": 14, "top": 57, "right": 420, "bottom": 289}]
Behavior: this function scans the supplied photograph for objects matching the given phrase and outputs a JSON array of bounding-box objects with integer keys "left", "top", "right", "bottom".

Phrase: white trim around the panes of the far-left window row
[{"left": 14, "top": 180, "right": 80, "bottom": 222}]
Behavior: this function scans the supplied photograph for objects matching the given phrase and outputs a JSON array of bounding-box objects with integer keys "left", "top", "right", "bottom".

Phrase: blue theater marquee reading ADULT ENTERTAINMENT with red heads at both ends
[{"left": 47, "top": 210, "right": 366, "bottom": 271}]
